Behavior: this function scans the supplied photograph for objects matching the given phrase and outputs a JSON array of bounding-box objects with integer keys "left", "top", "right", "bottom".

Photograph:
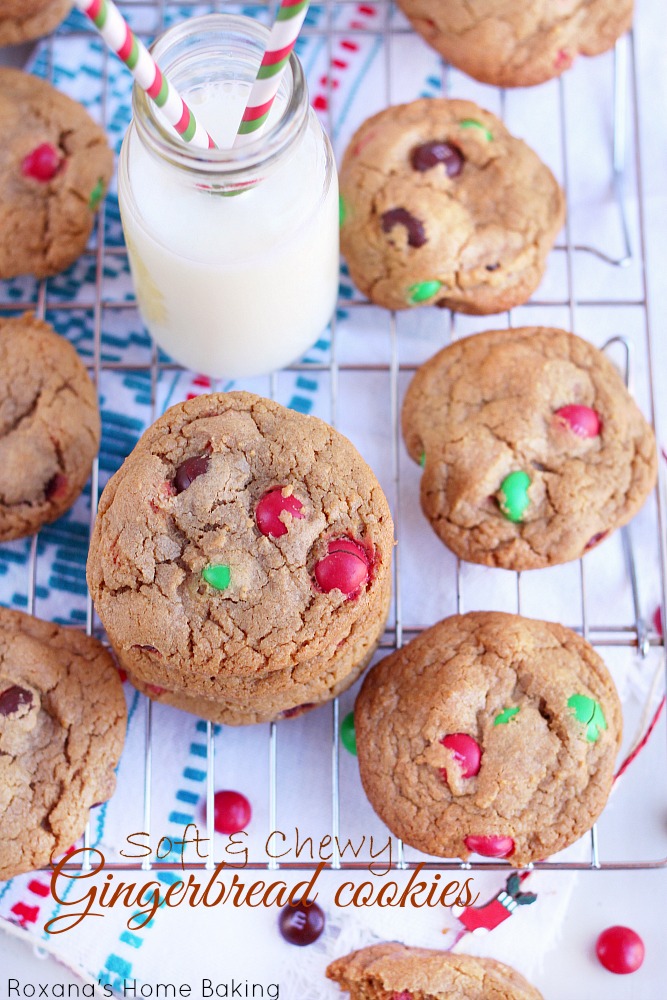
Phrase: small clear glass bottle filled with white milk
[{"left": 118, "top": 14, "right": 338, "bottom": 378}]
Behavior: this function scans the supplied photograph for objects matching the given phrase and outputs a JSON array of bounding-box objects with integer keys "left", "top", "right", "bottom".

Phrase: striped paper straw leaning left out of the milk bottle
[{"left": 74, "top": 0, "right": 215, "bottom": 149}]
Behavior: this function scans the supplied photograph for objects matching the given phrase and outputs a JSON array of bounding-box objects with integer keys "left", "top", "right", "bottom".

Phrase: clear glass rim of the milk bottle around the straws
[{"left": 132, "top": 14, "right": 309, "bottom": 184}]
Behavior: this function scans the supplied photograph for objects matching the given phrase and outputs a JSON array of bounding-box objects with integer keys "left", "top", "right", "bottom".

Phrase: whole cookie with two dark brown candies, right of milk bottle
[{"left": 340, "top": 98, "right": 565, "bottom": 313}]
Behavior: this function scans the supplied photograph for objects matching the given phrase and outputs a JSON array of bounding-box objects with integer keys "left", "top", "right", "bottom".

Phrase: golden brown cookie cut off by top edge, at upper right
[{"left": 398, "top": 0, "right": 633, "bottom": 87}]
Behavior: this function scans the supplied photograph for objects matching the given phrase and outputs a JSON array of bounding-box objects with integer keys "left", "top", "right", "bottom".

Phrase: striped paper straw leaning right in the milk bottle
[{"left": 234, "top": 0, "right": 309, "bottom": 146}]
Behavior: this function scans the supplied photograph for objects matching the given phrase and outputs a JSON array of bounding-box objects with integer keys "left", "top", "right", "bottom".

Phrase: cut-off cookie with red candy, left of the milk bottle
[{"left": 0, "top": 68, "right": 113, "bottom": 278}]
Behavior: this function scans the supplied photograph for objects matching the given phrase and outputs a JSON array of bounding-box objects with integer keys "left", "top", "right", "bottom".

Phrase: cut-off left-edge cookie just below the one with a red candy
[{"left": 0, "top": 313, "right": 100, "bottom": 541}]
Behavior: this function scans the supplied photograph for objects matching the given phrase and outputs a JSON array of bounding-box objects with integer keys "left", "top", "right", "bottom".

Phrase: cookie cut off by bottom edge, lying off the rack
[{"left": 326, "top": 941, "right": 542, "bottom": 1000}]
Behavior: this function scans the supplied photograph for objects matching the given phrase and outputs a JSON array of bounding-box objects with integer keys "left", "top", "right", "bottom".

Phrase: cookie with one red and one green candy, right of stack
[{"left": 402, "top": 327, "right": 657, "bottom": 570}]
